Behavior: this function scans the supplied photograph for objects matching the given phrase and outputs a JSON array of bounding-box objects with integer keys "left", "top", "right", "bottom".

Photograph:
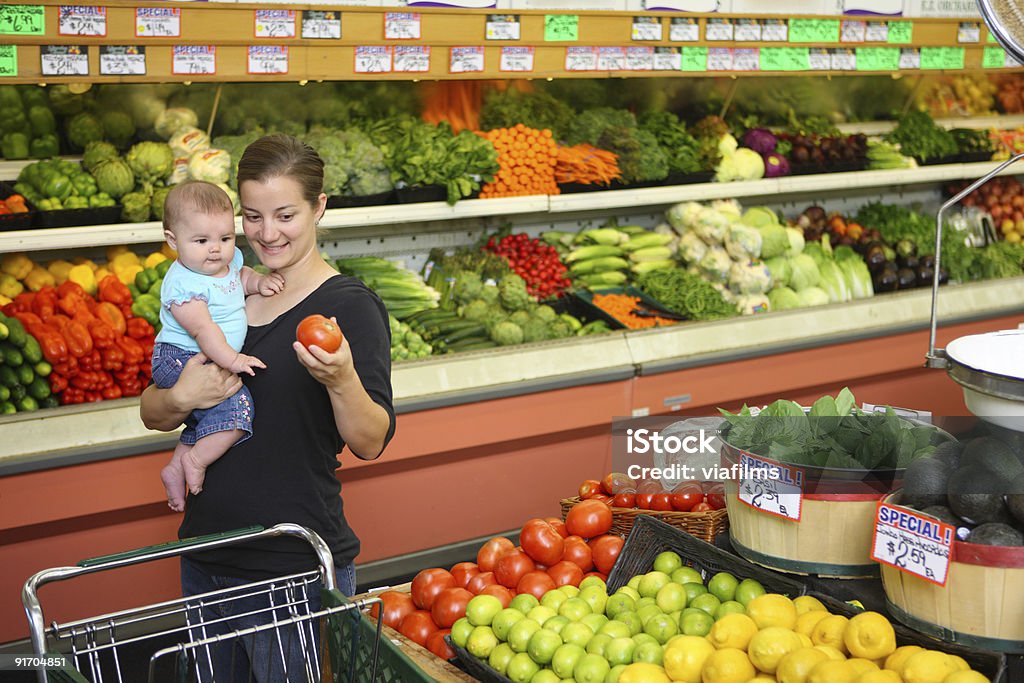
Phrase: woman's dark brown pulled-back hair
[{"left": 239, "top": 133, "right": 324, "bottom": 207}]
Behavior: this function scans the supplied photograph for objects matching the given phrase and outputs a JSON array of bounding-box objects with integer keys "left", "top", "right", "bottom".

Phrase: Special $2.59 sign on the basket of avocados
[{"left": 871, "top": 503, "right": 956, "bottom": 586}]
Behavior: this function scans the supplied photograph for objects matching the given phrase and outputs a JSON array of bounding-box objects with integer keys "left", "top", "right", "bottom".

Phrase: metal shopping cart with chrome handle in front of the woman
[{"left": 22, "top": 524, "right": 430, "bottom": 683}]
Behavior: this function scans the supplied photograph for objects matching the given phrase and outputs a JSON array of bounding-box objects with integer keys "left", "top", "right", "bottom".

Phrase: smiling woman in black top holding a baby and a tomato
[{"left": 140, "top": 134, "right": 394, "bottom": 680}]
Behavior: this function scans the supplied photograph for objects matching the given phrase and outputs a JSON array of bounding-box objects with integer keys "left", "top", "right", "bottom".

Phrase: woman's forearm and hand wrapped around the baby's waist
[{"left": 139, "top": 353, "right": 242, "bottom": 431}]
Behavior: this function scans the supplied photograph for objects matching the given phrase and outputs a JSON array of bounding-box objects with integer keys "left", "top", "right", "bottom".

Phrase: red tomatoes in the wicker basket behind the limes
[{"left": 580, "top": 472, "right": 725, "bottom": 512}]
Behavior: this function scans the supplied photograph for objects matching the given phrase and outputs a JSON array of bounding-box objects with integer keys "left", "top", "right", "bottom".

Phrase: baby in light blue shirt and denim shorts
[{"left": 153, "top": 182, "right": 285, "bottom": 512}]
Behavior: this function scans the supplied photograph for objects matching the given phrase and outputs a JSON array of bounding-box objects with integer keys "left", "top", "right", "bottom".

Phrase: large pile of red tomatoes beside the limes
[{"left": 372, "top": 501, "right": 625, "bottom": 659}]
